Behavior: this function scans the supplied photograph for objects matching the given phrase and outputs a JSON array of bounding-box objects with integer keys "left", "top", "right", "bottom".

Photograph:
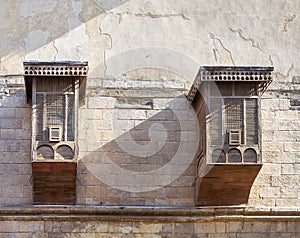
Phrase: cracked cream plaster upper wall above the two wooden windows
[{"left": 0, "top": 0, "right": 300, "bottom": 82}]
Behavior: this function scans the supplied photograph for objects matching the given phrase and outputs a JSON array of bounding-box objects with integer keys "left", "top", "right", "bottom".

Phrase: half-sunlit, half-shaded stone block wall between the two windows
[{"left": 77, "top": 68, "right": 197, "bottom": 206}]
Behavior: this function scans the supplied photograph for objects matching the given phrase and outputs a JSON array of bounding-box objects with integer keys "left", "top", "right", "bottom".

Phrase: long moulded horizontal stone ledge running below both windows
[{"left": 0, "top": 205, "right": 300, "bottom": 222}]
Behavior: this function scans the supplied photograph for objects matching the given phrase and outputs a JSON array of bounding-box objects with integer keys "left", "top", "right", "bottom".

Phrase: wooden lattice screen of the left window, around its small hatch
[{"left": 36, "top": 77, "right": 75, "bottom": 141}]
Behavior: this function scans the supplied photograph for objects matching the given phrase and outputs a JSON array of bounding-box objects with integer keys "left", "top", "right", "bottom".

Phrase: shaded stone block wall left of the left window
[{"left": 0, "top": 85, "right": 32, "bottom": 205}]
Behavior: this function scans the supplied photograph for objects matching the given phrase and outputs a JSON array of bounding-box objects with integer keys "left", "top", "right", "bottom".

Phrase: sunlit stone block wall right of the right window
[{"left": 249, "top": 77, "right": 300, "bottom": 206}]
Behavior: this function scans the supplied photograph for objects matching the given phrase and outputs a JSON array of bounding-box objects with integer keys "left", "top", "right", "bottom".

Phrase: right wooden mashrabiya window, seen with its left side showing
[{"left": 187, "top": 66, "right": 273, "bottom": 205}]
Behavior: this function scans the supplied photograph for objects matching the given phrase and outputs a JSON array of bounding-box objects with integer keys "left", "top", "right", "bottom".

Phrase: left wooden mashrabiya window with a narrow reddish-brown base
[{"left": 23, "top": 61, "right": 88, "bottom": 204}]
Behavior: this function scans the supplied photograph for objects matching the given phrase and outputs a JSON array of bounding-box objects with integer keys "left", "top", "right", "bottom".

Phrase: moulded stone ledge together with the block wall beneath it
[{"left": 0, "top": 206, "right": 300, "bottom": 238}]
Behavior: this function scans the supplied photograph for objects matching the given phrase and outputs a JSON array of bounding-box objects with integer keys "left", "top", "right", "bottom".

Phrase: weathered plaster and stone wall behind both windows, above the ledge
[{"left": 0, "top": 0, "right": 300, "bottom": 206}]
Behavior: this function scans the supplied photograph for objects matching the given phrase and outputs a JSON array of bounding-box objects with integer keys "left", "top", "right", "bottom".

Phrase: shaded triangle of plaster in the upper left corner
[{"left": 0, "top": 0, "right": 129, "bottom": 58}]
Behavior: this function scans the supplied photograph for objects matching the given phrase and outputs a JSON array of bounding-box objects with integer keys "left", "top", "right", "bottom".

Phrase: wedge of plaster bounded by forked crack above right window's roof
[{"left": 209, "top": 32, "right": 235, "bottom": 65}]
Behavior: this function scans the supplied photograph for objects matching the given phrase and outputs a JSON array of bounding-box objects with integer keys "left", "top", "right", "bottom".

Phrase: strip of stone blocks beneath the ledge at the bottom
[{"left": 0, "top": 221, "right": 300, "bottom": 238}]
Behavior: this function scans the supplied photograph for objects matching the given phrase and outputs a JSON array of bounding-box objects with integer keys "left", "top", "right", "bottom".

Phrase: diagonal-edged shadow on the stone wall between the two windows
[{"left": 77, "top": 96, "right": 198, "bottom": 206}]
